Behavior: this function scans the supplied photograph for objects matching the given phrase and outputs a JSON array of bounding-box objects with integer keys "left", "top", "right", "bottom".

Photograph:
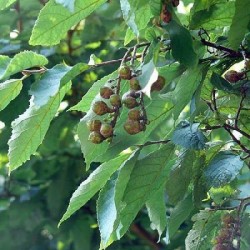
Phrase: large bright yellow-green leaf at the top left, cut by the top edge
[{"left": 29, "top": 0, "right": 106, "bottom": 46}]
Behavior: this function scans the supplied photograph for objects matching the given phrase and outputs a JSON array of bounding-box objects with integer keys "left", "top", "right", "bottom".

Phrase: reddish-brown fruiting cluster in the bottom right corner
[{"left": 215, "top": 214, "right": 238, "bottom": 250}]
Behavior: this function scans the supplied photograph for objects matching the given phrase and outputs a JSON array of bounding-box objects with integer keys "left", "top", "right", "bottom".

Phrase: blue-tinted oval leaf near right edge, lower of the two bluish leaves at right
[{"left": 204, "top": 151, "right": 244, "bottom": 187}]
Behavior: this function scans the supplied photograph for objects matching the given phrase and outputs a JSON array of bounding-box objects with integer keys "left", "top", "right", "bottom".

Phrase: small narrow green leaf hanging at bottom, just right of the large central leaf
[{"left": 146, "top": 185, "right": 167, "bottom": 240}]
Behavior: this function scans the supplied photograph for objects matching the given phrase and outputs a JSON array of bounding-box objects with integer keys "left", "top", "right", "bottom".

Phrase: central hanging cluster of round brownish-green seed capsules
[{"left": 87, "top": 65, "right": 165, "bottom": 144}]
